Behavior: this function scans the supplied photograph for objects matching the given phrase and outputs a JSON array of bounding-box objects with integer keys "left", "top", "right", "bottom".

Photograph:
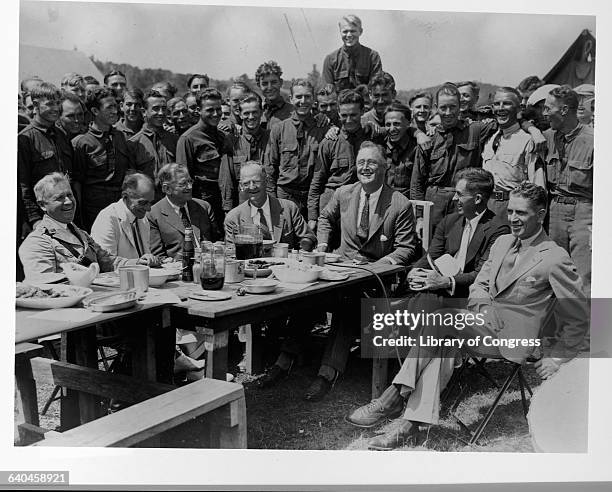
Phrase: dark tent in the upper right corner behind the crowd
[{"left": 544, "top": 29, "right": 595, "bottom": 87}]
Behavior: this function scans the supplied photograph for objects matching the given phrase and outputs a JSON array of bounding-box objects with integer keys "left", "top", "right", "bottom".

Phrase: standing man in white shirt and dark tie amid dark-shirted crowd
[{"left": 482, "top": 87, "right": 546, "bottom": 218}]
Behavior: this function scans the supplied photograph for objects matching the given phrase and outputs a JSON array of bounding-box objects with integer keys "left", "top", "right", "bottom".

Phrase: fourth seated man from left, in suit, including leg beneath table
[{"left": 225, "top": 161, "right": 316, "bottom": 388}]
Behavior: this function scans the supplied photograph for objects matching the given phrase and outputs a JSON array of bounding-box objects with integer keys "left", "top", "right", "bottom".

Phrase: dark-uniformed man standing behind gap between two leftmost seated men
[{"left": 72, "top": 87, "right": 133, "bottom": 230}]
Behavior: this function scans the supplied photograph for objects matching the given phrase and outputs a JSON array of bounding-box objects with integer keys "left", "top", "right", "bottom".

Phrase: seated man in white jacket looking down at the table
[{"left": 91, "top": 173, "right": 159, "bottom": 266}]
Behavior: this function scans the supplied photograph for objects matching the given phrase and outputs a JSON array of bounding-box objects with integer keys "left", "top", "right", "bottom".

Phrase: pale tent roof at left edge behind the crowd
[{"left": 19, "top": 44, "right": 104, "bottom": 87}]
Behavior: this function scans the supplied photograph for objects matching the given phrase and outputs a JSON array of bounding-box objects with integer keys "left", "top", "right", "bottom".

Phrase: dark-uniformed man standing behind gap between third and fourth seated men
[{"left": 176, "top": 88, "right": 233, "bottom": 229}]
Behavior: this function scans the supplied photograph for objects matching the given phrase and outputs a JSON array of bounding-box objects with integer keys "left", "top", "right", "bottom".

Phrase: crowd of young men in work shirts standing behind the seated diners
[{"left": 17, "top": 15, "right": 594, "bottom": 434}]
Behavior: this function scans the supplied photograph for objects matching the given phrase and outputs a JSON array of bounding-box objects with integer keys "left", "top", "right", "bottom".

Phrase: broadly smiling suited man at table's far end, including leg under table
[{"left": 305, "top": 141, "right": 416, "bottom": 401}]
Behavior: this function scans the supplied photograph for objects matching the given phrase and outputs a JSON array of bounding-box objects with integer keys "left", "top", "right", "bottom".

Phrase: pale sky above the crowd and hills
[{"left": 19, "top": 1, "right": 595, "bottom": 89}]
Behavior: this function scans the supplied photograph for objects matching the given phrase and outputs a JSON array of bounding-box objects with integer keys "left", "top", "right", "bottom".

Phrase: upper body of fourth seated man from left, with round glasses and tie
[{"left": 224, "top": 161, "right": 316, "bottom": 251}]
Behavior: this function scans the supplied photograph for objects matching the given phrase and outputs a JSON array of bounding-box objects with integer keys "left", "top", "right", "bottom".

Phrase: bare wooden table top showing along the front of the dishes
[{"left": 15, "top": 264, "right": 404, "bottom": 343}]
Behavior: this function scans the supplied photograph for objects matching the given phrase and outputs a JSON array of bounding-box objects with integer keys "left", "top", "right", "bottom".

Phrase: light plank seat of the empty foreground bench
[{"left": 35, "top": 379, "right": 244, "bottom": 447}]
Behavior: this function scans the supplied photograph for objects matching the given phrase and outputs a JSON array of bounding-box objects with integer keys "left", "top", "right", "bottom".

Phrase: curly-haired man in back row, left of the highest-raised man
[{"left": 255, "top": 60, "right": 293, "bottom": 130}]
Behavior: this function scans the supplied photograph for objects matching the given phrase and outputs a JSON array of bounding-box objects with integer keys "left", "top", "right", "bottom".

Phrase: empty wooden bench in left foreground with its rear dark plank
[{"left": 14, "top": 357, "right": 247, "bottom": 448}]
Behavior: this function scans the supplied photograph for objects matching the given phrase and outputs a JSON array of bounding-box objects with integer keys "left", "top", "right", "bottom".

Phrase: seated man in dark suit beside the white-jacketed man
[{"left": 148, "top": 163, "right": 221, "bottom": 258}]
